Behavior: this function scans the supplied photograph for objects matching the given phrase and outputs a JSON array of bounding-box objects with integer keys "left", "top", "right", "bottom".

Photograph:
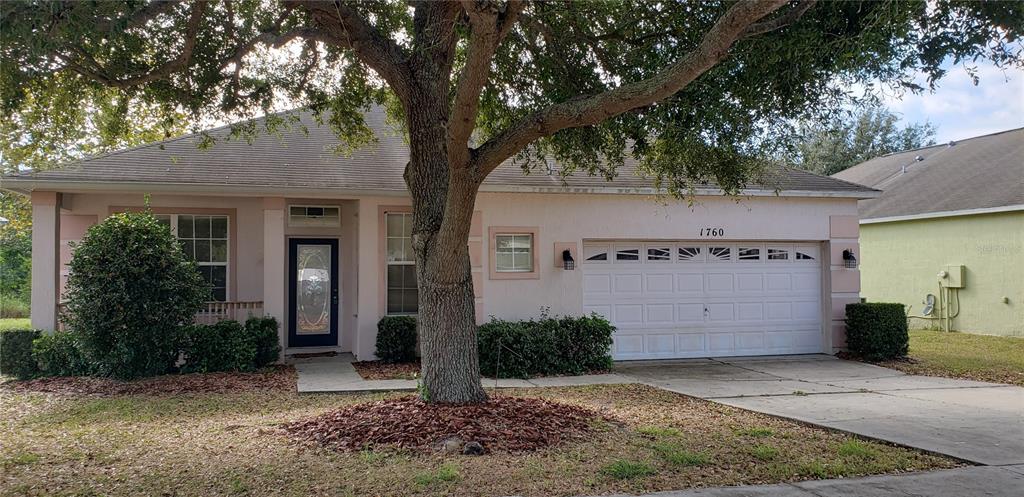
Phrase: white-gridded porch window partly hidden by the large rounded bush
[{"left": 156, "top": 214, "right": 230, "bottom": 301}]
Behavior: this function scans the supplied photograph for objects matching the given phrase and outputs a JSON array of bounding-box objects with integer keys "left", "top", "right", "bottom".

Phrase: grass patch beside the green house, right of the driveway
[{"left": 882, "top": 330, "right": 1024, "bottom": 386}]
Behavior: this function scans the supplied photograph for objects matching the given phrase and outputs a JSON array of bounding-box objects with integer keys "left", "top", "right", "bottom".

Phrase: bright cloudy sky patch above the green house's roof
[{"left": 883, "top": 64, "right": 1024, "bottom": 143}]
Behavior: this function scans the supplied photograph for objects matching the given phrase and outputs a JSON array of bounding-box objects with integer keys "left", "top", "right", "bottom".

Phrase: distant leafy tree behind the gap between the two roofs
[{"left": 787, "top": 106, "right": 935, "bottom": 176}]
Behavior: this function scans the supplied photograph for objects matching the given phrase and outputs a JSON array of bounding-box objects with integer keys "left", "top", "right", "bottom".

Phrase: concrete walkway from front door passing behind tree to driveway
[{"left": 291, "top": 354, "right": 637, "bottom": 394}]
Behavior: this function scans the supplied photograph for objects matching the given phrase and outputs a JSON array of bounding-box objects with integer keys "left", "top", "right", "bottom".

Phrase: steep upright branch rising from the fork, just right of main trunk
[{"left": 447, "top": 0, "right": 525, "bottom": 167}]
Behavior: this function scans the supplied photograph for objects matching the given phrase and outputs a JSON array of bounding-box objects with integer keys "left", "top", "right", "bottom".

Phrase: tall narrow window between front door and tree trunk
[{"left": 384, "top": 212, "right": 420, "bottom": 315}]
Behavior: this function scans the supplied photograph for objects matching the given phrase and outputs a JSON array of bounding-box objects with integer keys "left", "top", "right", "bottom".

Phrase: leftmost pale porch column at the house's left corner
[{"left": 32, "top": 192, "right": 60, "bottom": 331}]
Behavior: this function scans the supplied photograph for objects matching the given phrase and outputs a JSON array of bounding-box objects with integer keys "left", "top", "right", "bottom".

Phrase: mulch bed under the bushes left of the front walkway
[{"left": 0, "top": 366, "right": 296, "bottom": 397}]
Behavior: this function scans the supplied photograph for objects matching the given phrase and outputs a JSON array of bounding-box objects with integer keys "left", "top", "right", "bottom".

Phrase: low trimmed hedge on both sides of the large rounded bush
[{"left": 0, "top": 318, "right": 281, "bottom": 379}]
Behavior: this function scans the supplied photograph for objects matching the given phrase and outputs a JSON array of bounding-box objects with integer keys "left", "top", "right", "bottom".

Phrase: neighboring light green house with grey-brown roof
[{"left": 834, "top": 128, "right": 1024, "bottom": 336}]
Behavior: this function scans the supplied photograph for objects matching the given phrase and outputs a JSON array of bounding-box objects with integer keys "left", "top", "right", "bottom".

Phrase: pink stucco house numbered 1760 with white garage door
[{"left": 2, "top": 113, "right": 878, "bottom": 360}]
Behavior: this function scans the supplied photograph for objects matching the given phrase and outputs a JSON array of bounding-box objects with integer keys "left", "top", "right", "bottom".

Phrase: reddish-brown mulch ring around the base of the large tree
[{"left": 285, "top": 396, "right": 601, "bottom": 453}]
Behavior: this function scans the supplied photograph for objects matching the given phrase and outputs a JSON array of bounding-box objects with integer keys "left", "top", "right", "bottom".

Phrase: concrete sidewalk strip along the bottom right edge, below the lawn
[{"left": 585, "top": 466, "right": 1024, "bottom": 497}]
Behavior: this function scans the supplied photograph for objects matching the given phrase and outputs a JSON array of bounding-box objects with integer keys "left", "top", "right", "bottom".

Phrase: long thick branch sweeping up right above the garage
[{"left": 470, "top": 0, "right": 786, "bottom": 175}]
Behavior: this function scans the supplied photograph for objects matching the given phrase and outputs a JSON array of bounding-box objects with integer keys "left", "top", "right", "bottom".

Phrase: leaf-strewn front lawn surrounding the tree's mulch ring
[{"left": 0, "top": 385, "right": 959, "bottom": 496}]
